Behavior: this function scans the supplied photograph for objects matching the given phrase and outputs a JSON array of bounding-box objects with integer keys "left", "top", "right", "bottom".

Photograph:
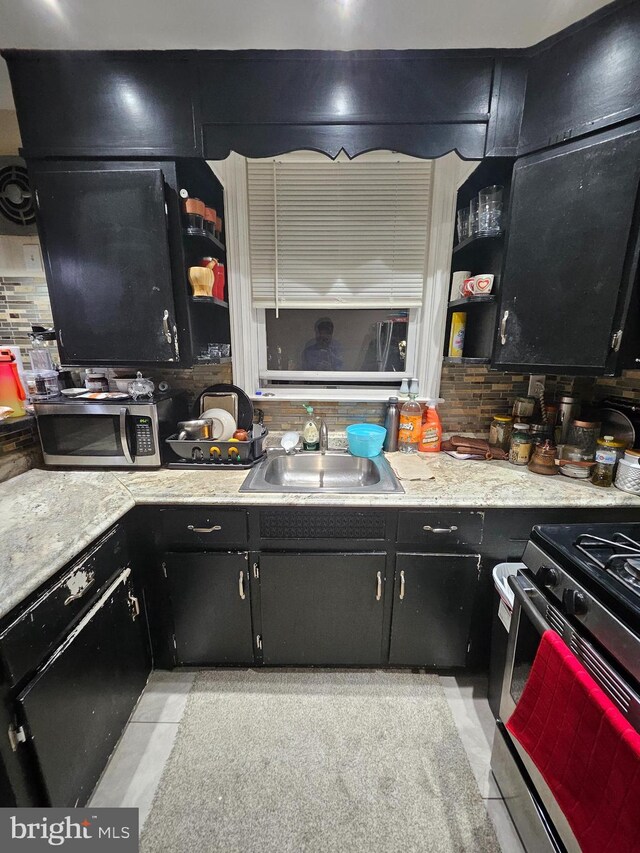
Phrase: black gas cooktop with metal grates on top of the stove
[{"left": 531, "top": 522, "right": 640, "bottom": 618}]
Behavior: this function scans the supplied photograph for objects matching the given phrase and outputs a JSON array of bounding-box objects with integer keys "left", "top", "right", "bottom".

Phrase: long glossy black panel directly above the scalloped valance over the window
[{"left": 198, "top": 50, "right": 494, "bottom": 124}]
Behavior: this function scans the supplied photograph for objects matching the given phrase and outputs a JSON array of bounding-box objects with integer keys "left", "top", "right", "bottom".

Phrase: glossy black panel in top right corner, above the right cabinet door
[{"left": 519, "top": 3, "right": 640, "bottom": 153}]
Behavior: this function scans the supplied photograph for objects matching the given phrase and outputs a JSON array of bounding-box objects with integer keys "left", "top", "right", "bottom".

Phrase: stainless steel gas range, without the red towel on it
[{"left": 491, "top": 523, "right": 640, "bottom": 853}]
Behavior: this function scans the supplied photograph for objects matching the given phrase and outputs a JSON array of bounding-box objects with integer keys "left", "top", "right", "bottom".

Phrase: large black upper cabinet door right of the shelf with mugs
[{"left": 494, "top": 123, "right": 640, "bottom": 375}]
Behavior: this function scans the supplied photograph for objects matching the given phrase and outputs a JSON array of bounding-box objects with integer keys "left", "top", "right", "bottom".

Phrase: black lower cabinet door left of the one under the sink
[{"left": 164, "top": 553, "right": 253, "bottom": 665}]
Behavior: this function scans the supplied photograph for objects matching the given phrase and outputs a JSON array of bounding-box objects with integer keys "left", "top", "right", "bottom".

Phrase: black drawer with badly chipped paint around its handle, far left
[{"left": 0, "top": 525, "right": 129, "bottom": 685}]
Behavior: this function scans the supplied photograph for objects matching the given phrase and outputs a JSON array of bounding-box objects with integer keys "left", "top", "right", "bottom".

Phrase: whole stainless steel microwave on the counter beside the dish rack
[{"left": 34, "top": 393, "right": 188, "bottom": 468}]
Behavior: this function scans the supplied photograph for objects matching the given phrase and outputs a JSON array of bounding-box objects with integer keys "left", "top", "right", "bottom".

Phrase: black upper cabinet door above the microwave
[{"left": 30, "top": 164, "right": 178, "bottom": 364}]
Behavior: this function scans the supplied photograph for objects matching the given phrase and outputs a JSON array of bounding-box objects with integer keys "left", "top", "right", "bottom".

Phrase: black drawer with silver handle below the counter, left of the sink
[{"left": 161, "top": 507, "right": 247, "bottom": 550}]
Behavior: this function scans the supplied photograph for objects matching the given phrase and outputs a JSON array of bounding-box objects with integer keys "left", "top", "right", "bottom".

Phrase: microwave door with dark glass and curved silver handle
[{"left": 35, "top": 403, "right": 135, "bottom": 468}]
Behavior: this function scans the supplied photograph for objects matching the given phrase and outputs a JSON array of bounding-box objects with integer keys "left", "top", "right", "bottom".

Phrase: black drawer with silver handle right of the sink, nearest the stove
[{"left": 398, "top": 509, "right": 484, "bottom": 549}]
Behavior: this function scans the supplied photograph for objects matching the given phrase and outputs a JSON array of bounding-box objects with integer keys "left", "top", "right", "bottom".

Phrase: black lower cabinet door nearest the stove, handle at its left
[{"left": 389, "top": 554, "right": 480, "bottom": 667}]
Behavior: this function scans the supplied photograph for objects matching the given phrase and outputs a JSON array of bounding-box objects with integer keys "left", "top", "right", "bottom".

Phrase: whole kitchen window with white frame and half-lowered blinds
[{"left": 210, "top": 152, "right": 466, "bottom": 400}]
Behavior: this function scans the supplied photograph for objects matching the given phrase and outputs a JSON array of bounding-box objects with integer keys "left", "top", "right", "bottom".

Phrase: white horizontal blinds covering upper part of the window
[{"left": 247, "top": 160, "right": 432, "bottom": 308}]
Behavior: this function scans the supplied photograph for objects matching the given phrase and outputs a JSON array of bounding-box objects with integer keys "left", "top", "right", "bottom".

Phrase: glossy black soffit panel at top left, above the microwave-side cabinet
[{"left": 4, "top": 51, "right": 201, "bottom": 157}]
